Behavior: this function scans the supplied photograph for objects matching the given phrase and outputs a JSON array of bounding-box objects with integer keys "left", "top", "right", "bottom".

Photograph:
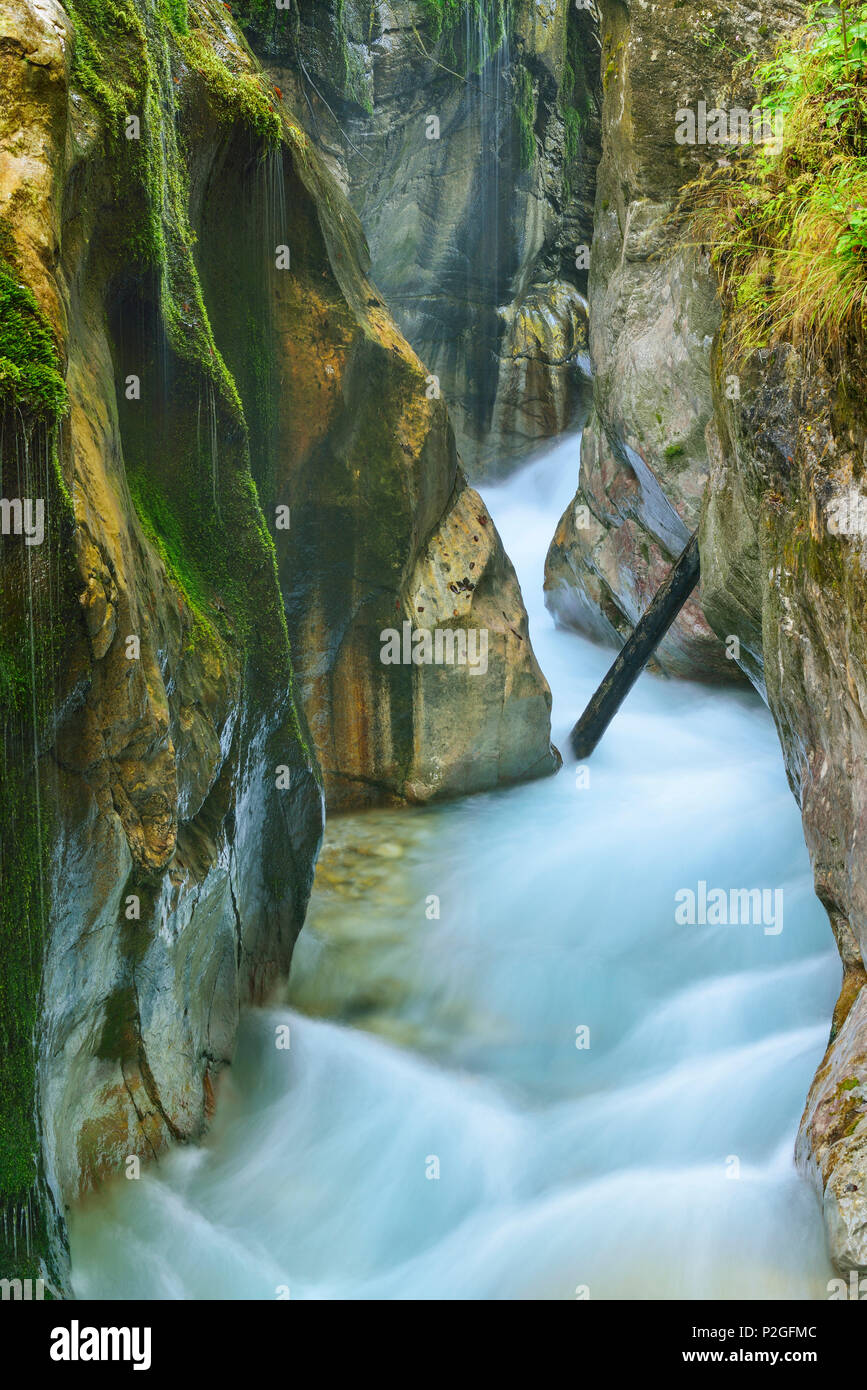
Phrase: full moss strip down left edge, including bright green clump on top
[{"left": 0, "top": 179, "right": 71, "bottom": 1276}]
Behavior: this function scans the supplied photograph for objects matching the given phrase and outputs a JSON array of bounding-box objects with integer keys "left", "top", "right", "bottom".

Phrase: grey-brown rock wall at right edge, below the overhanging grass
[{"left": 700, "top": 346, "right": 867, "bottom": 1270}]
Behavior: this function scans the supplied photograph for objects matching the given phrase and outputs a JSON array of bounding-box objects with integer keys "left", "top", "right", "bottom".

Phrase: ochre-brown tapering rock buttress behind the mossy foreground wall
[{"left": 200, "top": 120, "right": 559, "bottom": 809}]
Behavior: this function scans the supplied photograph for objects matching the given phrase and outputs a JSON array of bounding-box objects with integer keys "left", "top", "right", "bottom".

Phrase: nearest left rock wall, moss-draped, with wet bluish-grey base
[{"left": 0, "top": 0, "right": 322, "bottom": 1289}]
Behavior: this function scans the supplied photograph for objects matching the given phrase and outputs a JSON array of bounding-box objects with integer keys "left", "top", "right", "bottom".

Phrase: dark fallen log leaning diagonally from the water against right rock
[{"left": 570, "top": 531, "right": 700, "bottom": 760}]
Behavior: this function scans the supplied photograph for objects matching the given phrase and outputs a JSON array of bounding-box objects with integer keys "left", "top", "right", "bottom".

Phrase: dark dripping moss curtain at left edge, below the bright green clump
[{"left": 0, "top": 436, "right": 76, "bottom": 1277}]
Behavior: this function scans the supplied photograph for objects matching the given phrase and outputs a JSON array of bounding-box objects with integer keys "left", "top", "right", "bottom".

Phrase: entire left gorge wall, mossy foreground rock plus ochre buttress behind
[{"left": 0, "top": 0, "right": 557, "bottom": 1289}]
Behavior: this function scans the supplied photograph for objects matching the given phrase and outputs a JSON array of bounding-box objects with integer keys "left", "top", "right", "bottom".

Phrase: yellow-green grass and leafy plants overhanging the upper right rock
[{"left": 682, "top": 0, "right": 867, "bottom": 353}]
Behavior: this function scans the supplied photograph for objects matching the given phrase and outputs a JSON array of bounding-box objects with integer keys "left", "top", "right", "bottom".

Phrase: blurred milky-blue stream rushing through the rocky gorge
[{"left": 71, "top": 439, "right": 839, "bottom": 1298}]
